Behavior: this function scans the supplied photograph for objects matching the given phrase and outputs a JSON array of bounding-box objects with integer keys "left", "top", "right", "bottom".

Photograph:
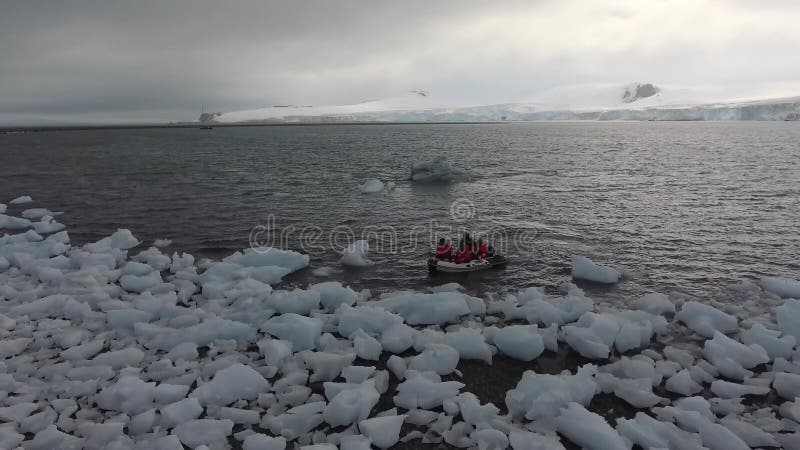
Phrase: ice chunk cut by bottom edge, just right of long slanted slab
[{"left": 617, "top": 412, "right": 701, "bottom": 450}]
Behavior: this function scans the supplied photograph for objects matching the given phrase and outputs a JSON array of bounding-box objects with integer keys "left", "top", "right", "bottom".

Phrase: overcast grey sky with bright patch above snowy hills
[{"left": 0, "top": 0, "right": 800, "bottom": 125}]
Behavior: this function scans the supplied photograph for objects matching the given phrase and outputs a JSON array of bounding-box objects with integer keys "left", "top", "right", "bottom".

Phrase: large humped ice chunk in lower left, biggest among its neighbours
[{"left": 191, "top": 363, "right": 269, "bottom": 406}]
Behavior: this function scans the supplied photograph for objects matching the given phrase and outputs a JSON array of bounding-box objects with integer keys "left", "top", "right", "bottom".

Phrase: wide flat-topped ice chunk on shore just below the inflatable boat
[{"left": 374, "top": 292, "right": 470, "bottom": 325}]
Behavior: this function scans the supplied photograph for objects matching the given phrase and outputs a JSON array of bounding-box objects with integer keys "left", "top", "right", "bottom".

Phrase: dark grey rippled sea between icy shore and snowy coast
[{"left": 0, "top": 122, "right": 800, "bottom": 300}]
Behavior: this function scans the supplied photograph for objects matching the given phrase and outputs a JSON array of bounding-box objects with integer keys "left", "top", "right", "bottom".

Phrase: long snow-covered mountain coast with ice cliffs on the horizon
[{"left": 213, "top": 83, "right": 800, "bottom": 123}]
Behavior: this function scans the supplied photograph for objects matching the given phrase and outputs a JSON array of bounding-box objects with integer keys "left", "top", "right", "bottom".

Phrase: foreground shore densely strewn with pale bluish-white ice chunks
[{"left": 0, "top": 202, "right": 800, "bottom": 450}]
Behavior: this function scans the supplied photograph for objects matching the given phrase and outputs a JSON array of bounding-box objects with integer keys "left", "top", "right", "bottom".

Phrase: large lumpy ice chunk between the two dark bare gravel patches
[{"left": 506, "top": 364, "right": 597, "bottom": 420}]
